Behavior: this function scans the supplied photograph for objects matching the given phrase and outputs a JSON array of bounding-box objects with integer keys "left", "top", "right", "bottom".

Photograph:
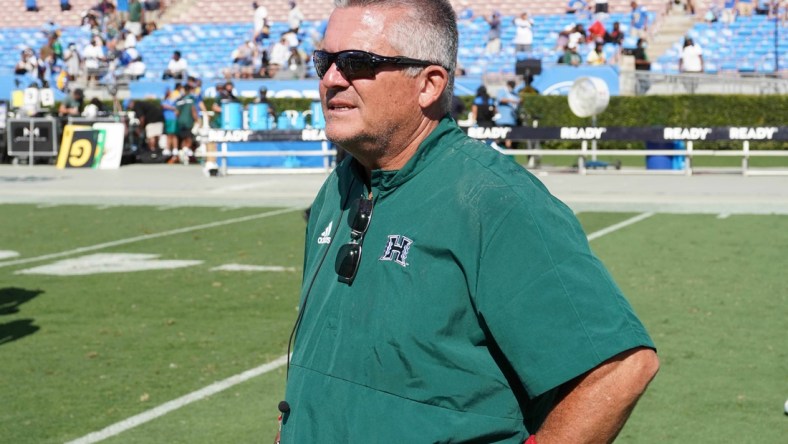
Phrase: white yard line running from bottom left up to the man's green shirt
[{"left": 66, "top": 355, "right": 287, "bottom": 444}]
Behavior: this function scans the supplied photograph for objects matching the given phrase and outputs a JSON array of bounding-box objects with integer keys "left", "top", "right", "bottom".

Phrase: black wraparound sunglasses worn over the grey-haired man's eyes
[{"left": 312, "top": 49, "right": 440, "bottom": 80}]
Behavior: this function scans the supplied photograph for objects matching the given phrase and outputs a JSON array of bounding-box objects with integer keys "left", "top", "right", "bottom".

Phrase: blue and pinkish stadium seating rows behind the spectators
[{"left": 0, "top": 0, "right": 788, "bottom": 90}]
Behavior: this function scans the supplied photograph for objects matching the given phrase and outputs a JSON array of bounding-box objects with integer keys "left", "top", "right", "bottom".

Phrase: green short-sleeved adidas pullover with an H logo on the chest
[{"left": 282, "top": 117, "right": 653, "bottom": 444}]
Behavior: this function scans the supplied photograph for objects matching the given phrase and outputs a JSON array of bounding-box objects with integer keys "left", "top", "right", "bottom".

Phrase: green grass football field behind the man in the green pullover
[{"left": 0, "top": 205, "right": 788, "bottom": 444}]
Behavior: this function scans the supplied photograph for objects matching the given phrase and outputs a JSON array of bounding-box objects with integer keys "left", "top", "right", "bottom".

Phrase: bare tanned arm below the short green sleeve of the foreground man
[{"left": 536, "top": 347, "right": 659, "bottom": 444}]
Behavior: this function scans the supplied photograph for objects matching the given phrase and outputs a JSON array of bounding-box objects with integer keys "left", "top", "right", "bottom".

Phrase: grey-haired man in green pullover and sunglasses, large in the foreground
[{"left": 279, "top": 0, "right": 658, "bottom": 444}]
